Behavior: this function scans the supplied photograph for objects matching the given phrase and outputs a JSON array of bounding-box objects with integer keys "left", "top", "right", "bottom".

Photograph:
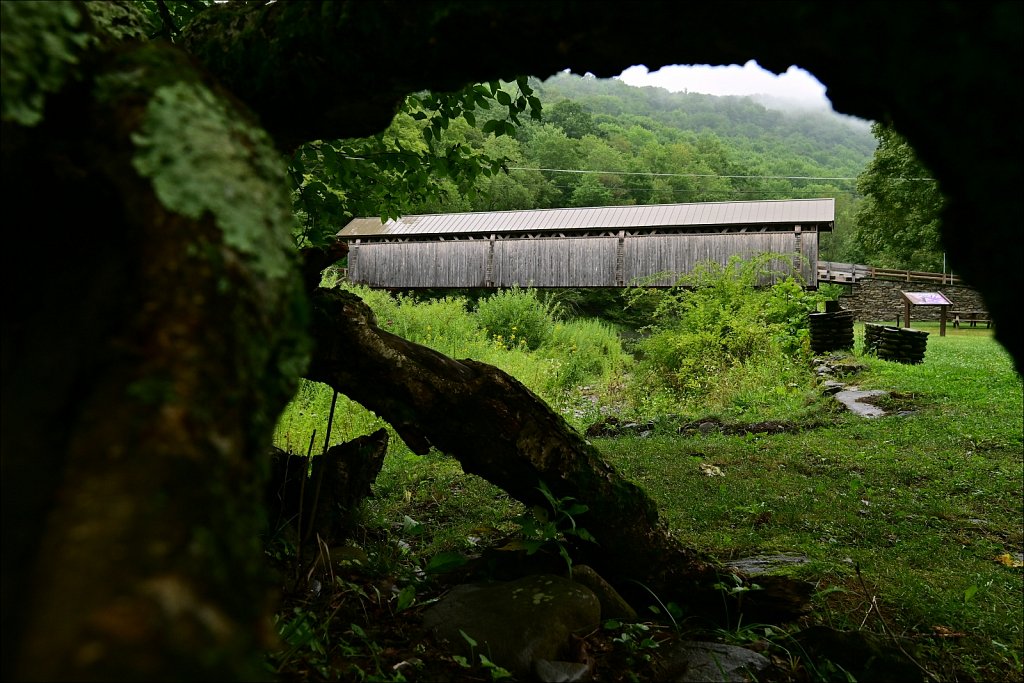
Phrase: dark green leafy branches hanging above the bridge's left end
[{"left": 289, "top": 76, "right": 541, "bottom": 246}]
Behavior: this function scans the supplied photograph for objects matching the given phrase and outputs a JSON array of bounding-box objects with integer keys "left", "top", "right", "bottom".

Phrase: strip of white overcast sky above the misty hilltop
[{"left": 618, "top": 59, "right": 831, "bottom": 109}]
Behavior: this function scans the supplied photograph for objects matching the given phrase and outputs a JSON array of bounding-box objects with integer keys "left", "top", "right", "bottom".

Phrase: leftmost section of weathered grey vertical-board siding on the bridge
[{"left": 348, "top": 241, "right": 490, "bottom": 288}]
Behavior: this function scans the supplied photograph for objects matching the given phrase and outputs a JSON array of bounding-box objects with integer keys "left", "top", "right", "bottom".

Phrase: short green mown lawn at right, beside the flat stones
[{"left": 599, "top": 324, "right": 1024, "bottom": 680}]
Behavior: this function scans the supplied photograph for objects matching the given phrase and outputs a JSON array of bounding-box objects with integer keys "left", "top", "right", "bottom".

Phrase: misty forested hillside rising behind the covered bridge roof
[{"left": 390, "top": 74, "right": 877, "bottom": 260}]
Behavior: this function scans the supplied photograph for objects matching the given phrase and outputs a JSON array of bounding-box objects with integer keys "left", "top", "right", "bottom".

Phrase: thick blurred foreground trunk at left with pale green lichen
[{"left": 2, "top": 40, "right": 307, "bottom": 681}]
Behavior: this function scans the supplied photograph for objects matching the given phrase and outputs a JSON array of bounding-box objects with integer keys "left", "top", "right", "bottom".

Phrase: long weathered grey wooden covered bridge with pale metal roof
[{"left": 338, "top": 199, "right": 836, "bottom": 289}]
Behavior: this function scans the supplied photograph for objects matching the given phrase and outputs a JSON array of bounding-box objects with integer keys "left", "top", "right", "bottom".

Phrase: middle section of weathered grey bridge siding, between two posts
[{"left": 494, "top": 238, "right": 617, "bottom": 287}]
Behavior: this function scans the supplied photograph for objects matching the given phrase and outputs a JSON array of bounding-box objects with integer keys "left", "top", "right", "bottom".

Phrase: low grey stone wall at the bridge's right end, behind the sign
[{"left": 840, "top": 279, "right": 988, "bottom": 323}]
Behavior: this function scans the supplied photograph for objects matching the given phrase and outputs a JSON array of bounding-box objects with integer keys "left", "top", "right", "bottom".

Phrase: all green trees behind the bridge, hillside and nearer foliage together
[{"left": 293, "top": 73, "right": 943, "bottom": 271}]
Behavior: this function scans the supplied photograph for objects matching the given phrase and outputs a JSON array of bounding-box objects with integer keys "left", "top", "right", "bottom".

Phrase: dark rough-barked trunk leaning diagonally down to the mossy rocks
[{"left": 306, "top": 289, "right": 721, "bottom": 609}]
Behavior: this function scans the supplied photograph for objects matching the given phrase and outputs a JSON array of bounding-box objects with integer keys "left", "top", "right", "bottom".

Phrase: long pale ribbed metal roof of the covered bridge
[{"left": 338, "top": 198, "right": 836, "bottom": 239}]
